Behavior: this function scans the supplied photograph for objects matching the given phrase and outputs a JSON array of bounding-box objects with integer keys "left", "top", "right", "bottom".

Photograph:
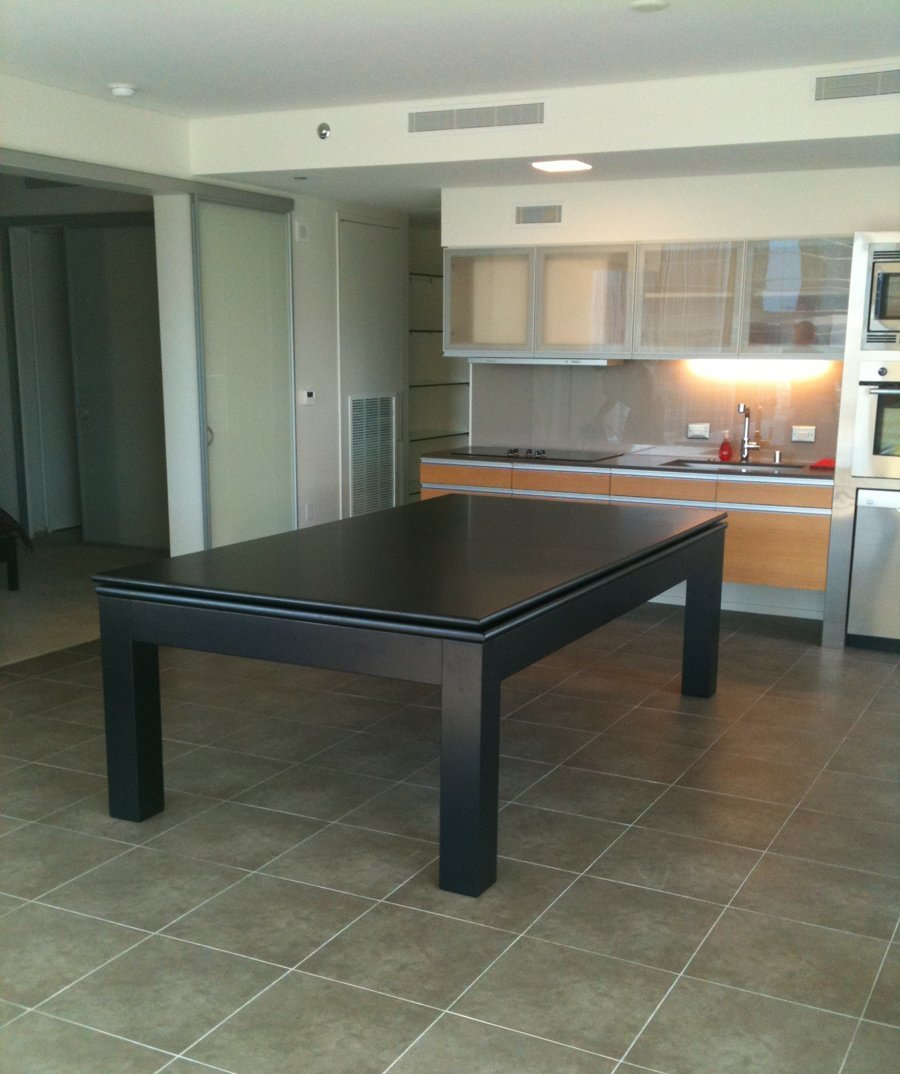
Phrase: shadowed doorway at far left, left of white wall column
[{"left": 2, "top": 206, "right": 169, "bottom": 549}]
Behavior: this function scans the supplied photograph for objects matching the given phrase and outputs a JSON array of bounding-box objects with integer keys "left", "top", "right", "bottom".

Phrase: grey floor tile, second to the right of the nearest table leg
[{"left": 590, "top": 827, "right": 759, "bottom": 903}]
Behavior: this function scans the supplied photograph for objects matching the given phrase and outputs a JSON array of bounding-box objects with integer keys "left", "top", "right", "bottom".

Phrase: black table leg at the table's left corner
[{"left": 99, "top": 597, "right": 164, "bottom": 821}]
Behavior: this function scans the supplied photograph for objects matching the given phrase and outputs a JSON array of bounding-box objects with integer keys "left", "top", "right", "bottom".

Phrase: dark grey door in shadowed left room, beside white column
[{"left": 66, "top": 226, "right": 169, "bottom": 549}]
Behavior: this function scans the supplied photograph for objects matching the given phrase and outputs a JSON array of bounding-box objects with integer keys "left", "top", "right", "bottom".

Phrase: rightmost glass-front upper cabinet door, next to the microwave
[{"left": 741, "top": 237, "right": 853, "bottom": 353}]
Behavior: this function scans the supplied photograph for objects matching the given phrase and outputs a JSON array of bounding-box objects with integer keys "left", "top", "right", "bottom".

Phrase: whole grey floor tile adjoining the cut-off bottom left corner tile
[{"left": 43, "top": 937, "right": 284, "bottom": 1053}]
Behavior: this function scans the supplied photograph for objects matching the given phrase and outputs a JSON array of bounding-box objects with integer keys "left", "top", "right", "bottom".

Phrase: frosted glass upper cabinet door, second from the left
[{"left": 543, "top": 246, "right": 635, "bottom": 353}]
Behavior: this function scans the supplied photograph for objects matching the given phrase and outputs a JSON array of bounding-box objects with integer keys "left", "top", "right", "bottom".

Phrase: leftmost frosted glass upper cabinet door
[{"left": 444, "top": 247, "right": 535, "bottom": 355}]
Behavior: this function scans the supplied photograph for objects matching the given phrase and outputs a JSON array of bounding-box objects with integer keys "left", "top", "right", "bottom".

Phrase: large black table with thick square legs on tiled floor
[{"left": 95, "top": 495, "right": 725, "bottom": 896}]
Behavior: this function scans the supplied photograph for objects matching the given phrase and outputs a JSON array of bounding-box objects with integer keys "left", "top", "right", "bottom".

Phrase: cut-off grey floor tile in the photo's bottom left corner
[{"left": 0, "top": 1013, "right": 168, "bottom": 1074}]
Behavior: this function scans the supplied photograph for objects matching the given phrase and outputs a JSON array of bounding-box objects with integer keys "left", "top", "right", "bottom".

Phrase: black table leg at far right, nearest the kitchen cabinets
[{"left": 681, "top": 527, "right": 725, "bottom": 697}]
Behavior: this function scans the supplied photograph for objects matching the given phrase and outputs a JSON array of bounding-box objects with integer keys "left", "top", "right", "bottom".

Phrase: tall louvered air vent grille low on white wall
[{"left": 350, "top": 395, "right": 396, "bottom": 514}]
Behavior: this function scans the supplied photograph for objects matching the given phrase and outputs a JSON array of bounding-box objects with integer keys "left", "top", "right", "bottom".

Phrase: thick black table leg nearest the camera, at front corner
[{"left": 439, "top": 641, "right": 500, "bottom": 896}]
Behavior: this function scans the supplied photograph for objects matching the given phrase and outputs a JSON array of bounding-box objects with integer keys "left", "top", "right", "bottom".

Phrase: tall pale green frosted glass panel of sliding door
[{"left": 198, "top": 202, "right": 296, "bottom": 547}]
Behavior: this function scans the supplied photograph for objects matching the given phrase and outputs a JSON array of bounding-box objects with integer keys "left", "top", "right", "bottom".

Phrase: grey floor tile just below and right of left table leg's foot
[{"left": 144, "top": 802, "right": 324, "bottom": 869}]
